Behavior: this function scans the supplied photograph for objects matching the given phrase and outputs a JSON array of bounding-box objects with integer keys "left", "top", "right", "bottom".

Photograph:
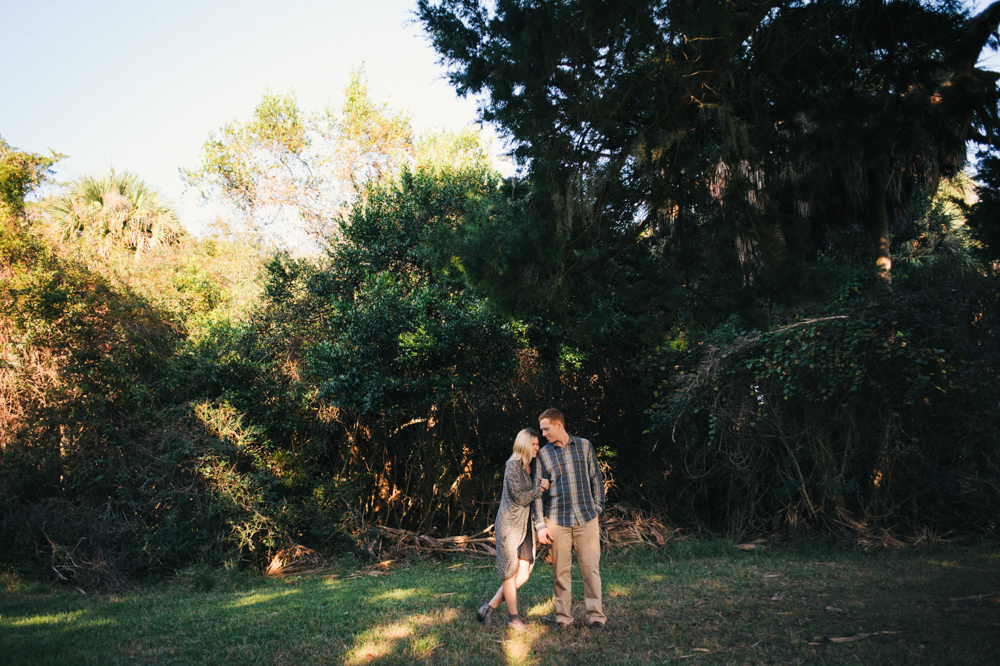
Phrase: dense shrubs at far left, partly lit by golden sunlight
[{"left": 0, "top": 220, "right": 356, "bottom": 587}]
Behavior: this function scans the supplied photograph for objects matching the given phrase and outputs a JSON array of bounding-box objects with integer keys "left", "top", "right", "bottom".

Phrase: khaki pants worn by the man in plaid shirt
[{"left": 545, "top": 518, "right": 607, "bottom": 624}]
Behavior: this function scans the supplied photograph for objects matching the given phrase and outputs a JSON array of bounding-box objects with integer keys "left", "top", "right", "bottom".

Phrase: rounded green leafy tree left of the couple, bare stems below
[{"left": 254, "top": 157, "right": 521, "bottom": 530}]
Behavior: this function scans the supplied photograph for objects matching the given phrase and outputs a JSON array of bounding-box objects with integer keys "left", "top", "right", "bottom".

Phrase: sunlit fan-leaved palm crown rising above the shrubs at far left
[{"left": 46, "top": 169, "right": 180, "bottom": 256}]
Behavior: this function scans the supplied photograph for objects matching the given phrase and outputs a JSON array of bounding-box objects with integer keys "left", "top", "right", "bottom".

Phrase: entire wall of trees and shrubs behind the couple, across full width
[{"left": 0, "top": 0, "right": 1000, "bottom": 586}]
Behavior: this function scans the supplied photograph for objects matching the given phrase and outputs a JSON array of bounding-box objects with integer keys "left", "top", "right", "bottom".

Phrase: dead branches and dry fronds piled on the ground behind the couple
[{"left": 358, "top": 504, "right": 677, "bottom": 560}]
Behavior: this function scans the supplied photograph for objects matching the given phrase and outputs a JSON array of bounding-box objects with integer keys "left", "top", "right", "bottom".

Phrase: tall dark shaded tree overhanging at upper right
[{"left": 419, "top": 0, "right": 1000, "bottom": 306}]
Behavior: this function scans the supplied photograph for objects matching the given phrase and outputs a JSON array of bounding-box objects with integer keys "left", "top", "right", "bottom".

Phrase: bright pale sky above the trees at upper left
[{"left": 0, "top": 0, "right": 484, "bottom": 226}]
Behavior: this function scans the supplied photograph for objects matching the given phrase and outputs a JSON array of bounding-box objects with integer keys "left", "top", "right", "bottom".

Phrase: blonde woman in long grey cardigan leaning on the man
[{"left": 476, "top": 428, "right": 549, "bottom": 631}]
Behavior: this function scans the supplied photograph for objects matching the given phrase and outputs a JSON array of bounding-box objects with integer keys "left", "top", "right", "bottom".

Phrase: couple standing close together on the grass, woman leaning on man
[{"left": 477, "top": 409, "right": 606, "bottom": 631}]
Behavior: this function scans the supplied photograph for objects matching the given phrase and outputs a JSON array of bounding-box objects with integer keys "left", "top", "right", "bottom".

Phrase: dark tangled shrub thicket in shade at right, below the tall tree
[{"left": 651, "top": 272, "right": 1000, "bottom": 534}]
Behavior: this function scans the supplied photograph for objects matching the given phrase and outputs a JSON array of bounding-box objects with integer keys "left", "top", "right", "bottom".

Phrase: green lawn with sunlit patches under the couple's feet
[{"left": 0, "top": 541, "right": 1000, "bottom": 665}]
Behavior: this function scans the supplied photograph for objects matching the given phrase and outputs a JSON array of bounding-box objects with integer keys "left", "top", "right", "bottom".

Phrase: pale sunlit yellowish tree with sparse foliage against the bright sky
[{"left": 181, "top": 70, "right": 413, "bottom": 246}]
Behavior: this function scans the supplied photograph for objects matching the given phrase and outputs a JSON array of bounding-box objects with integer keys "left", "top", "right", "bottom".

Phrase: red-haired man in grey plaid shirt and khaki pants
[{"left": 532, "top": 409, "right": 607, "bottom": 629}]
